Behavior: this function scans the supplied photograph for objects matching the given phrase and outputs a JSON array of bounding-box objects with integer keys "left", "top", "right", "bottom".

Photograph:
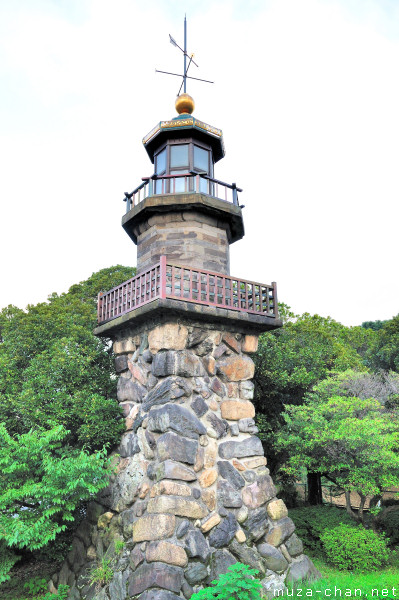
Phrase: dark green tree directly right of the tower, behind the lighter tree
[{"left": 254, "top": 312, "right": 376, "bottom": 474}]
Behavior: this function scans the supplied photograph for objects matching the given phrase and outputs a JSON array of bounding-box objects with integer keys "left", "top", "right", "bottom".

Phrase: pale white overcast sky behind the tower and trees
[{"left": 0, "top": 0, "right": 399, "bottom": 325}]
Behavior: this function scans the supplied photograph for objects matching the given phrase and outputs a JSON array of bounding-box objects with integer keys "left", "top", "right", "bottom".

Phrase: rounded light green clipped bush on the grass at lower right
[{"left": 320, "top": 524, "right": 389, "bottom": 571}]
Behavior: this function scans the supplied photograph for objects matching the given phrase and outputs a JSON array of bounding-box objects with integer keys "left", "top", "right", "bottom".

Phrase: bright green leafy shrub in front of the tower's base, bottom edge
[{"left": 191, "top": 563, "right": 262, "bottom": 600}]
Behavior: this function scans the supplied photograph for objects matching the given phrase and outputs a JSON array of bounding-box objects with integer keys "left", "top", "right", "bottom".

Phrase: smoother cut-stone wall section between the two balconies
[{"left": 135, "top": 211, "right": 230, "bottom": 275}]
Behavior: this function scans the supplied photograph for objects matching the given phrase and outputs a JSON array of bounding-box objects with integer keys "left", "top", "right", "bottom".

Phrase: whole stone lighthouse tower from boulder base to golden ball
[{"left": 56, "top": 89, "right": 316, "bottom": 600}]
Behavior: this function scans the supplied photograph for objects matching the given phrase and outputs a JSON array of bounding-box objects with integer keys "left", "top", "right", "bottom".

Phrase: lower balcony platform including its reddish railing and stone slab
[{"left": 94, "top": 256, "right": 282, "bottom": 337}]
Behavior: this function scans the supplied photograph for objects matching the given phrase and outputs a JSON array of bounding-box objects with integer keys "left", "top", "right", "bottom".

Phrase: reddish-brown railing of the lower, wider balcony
[{"left": 97, "top": 256, "right": 278, "bottom": 324}]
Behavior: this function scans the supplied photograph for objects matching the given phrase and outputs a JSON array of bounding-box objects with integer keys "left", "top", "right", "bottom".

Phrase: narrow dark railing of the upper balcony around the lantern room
[{"left": 123, "top": 172, "right": 242, "bottom": 212}]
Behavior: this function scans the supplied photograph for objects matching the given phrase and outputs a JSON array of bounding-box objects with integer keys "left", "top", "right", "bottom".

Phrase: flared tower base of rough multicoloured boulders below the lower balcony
[{"left": 54, "top": 322, "right": 317, "bottom": 600}]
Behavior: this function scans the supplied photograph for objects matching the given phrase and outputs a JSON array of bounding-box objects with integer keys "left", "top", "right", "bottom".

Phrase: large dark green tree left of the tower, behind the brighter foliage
[{"left": 0, "top": 266, "right": 134, "bottom": 450}]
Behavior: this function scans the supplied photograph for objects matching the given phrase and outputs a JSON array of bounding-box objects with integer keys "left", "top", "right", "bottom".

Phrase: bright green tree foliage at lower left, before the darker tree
[{"left": 0, "top": 425, "right": 109, "bottom": 550}]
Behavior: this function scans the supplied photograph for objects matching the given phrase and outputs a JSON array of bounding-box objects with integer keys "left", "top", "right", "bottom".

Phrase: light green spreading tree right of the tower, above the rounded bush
[{"left": 278, "top": 372, "right": 399, "bottom": 521}]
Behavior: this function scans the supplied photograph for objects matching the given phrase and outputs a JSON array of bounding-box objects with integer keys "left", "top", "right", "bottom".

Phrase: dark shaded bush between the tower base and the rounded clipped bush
[{"left": 290, "top": 506, "right": 353, "bottom": 556}]
